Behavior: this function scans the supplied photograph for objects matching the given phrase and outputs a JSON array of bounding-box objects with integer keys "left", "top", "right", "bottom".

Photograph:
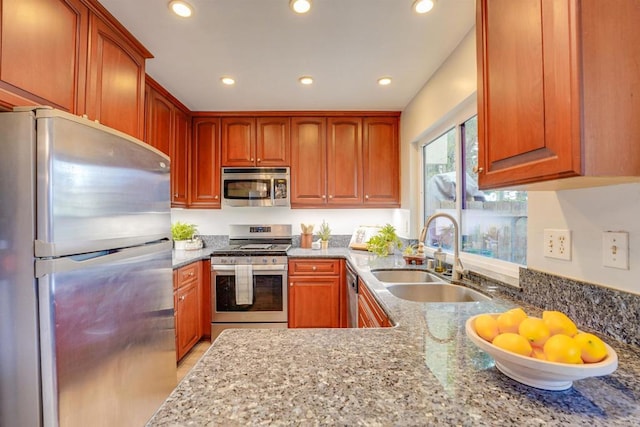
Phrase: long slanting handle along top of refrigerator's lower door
[{"left": 35, "top": 240, "right": 173, "bottom": 279}]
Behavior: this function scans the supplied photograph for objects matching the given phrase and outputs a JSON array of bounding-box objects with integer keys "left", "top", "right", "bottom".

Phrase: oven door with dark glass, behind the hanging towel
[{"left": 211, "top": 264, "right": 287, "bottom": 323}]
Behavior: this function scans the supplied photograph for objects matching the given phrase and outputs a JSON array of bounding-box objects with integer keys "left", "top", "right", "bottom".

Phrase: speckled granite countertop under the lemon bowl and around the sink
[{"left": 148, "top": 249, "right": 640, "bottom": 426}]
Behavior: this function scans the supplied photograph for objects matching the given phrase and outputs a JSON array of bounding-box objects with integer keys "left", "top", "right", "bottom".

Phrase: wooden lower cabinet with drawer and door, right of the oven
[{"left": 289, "top": 259, "right": 345, "bottom": 328}]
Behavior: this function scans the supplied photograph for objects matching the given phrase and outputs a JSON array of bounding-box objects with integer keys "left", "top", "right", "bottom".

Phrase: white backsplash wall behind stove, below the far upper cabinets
[{"left": 171, "top": 208, "right": 408, "bottom": 237}]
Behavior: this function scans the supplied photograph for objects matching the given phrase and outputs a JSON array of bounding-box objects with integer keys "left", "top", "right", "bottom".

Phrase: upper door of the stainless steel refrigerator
[{"left": 33, "top": 110, "right": 171, "bottom": 257}]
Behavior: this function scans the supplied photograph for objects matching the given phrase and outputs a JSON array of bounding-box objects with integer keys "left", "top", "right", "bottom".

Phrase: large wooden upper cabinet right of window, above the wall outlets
[{"left": 476, "top": 0, "right": 640, "bottom": 189}]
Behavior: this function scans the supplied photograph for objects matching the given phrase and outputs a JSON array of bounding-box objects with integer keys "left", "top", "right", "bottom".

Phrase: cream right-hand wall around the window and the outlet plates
[{"left": 401, "top": 29, "right": 640, "bottom": 294}]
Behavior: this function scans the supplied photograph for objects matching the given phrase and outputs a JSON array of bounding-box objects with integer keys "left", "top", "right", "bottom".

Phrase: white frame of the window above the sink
[{"left": 417, "top": 94, "right": 528, "bottom": 287}]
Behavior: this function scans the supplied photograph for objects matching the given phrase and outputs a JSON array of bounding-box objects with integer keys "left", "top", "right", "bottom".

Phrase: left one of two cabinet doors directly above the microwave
[{"left": 222, "top": 117, "right": 256, "bottom": 166}]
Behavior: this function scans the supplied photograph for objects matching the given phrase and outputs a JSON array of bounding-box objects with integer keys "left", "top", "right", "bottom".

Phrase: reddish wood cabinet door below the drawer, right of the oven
[{"left": 289, "top": 276, "right": 340, "bottom": 328}]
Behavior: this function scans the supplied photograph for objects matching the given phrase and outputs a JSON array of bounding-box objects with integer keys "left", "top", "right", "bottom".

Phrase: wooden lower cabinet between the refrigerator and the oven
[{"left": 173, "top": 262, "right": 202, "bottom": 360}]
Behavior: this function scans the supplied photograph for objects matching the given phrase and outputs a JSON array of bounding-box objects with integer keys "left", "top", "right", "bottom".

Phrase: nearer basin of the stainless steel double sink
[{"left": 385, "top": 283, "right": 491, "bottom": 302}]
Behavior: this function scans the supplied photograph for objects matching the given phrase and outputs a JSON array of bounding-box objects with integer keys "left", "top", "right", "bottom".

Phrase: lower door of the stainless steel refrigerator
[{"left": 36, "top": 242, "right": 176, "bottom": 426}]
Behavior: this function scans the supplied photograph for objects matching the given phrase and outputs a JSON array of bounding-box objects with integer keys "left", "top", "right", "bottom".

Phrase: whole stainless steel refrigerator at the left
[{"left": 0, "top": 108, "right": 176, "bottom": 427}]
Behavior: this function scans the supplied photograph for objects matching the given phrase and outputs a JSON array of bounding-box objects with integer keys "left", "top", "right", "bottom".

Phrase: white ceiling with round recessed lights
[{"left": 100, "top": 0, "right": 475, "bottom": 111}]
